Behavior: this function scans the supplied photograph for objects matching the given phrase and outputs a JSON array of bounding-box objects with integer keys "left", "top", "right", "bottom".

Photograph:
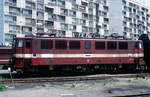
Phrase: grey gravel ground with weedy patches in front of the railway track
[{"left": 0, "top": 77, "right": 150, "bottom": 97}]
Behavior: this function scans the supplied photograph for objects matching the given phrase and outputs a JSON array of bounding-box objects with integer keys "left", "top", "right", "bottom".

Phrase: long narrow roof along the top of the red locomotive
[{"left": 17, "top": 36, "right": 141, "bottom": 41}]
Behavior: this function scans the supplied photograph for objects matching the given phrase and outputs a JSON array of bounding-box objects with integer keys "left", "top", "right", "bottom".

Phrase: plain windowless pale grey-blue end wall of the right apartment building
[{"left": 108, "top": 0, "right": 123, "bottom": 35}]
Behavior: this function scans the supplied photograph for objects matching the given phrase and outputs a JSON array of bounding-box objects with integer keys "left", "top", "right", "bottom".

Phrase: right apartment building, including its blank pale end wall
[{"left": 108, "top": 0, "right": 150, "bottom": 39}]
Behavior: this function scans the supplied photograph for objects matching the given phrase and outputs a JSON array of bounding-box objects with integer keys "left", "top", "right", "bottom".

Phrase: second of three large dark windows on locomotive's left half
[{"left": 55, "top": 40, "right": 67, "bottom": 49}]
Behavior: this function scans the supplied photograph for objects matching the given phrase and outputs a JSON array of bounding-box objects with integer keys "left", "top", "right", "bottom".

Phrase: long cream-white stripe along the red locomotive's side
[{"left": 14, "top": 53, "right": 144, "bottom": 58}]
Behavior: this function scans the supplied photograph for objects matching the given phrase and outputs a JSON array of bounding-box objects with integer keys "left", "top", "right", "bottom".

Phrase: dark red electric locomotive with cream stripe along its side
[{"left": 0, "top": 36, "right": 148, "bottom": 72}]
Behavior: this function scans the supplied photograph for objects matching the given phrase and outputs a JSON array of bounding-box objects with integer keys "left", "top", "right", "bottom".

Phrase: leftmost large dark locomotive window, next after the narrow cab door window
[{"left": 41, "top": 40, "right": 53, "bottom": 49}]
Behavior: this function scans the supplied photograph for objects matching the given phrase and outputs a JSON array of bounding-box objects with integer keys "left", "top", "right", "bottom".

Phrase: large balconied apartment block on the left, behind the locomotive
[{"left": 0, "top": 0, "right": 109, "bottom": 45}]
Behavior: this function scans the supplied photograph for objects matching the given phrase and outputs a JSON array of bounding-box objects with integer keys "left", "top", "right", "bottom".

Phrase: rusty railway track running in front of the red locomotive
[{"left": 0, "top": 73, "right": 150, "bottom": 84}]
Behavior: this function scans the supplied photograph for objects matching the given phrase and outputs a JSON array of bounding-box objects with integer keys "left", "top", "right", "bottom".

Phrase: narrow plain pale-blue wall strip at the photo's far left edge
[{"left": 0, "top": 0, "right": 4, "bottom": 45}]
